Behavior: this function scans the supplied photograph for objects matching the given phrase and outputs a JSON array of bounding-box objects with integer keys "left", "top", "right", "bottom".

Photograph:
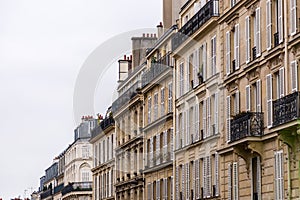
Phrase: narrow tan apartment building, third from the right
[{"left": 141, "top": 23, "right": 176, "bottom": 200}]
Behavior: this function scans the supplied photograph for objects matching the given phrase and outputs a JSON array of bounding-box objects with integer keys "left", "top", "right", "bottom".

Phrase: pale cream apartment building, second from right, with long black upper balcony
[{"left": 172, "top": 0, "right": 223, "bottom": 200}]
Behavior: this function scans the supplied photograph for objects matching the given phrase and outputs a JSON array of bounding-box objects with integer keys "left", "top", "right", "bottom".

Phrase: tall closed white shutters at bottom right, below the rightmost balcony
[{"left": 274, "top": 150, "right": 284, "bottom": 200}]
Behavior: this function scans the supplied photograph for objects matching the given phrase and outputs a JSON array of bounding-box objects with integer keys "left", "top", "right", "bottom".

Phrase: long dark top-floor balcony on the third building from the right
[{"left": 142, "top": 53, "right": 170, "bottom": 88}]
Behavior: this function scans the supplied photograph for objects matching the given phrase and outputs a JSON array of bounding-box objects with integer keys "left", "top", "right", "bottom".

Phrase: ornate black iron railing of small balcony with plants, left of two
[{"left": 230, "top": 112, "right": 264, "bottom": 142}]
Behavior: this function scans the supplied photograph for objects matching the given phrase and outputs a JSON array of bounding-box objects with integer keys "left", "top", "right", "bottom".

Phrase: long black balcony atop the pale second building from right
[{"left": 172, "top": 0, "right": 219, "bottom": 51}]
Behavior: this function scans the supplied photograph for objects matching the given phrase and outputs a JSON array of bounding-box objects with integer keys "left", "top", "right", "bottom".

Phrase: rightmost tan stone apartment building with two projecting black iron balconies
[{"left": 218, "top": 0, "right": 300, "bottom": 199}]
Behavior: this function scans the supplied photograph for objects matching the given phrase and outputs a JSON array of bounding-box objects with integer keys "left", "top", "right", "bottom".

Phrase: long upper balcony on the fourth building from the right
[{"left": 112, "top": 81, "right": 140, "bottom": 113}]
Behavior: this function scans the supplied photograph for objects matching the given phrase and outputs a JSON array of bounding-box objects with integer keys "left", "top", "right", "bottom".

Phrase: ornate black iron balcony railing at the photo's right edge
[{"left": 273, "top": 92, "right": 300, "bottom": 126}]
